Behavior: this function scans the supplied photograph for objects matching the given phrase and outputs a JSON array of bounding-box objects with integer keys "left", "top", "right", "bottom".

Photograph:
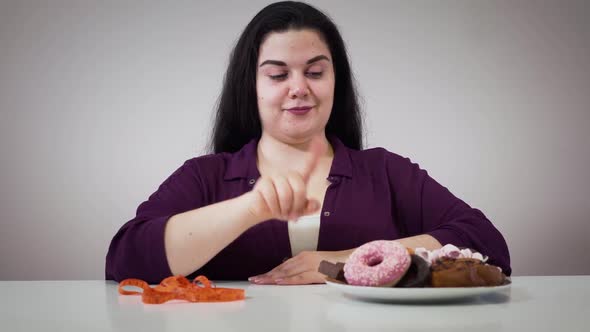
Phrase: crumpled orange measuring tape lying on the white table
[{"left": 119, "top": 276, "right": 245, "bottom": 304}]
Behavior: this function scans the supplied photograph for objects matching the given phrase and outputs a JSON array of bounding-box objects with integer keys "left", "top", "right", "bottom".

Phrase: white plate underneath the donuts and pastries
[{"left": 326, "top": 280, "right": 511, "bottom": 302}]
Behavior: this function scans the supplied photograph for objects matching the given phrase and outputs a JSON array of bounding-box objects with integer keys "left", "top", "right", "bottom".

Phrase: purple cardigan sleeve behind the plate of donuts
[{"left": 387, "top": 152, "right": 512, "bottom": 275}]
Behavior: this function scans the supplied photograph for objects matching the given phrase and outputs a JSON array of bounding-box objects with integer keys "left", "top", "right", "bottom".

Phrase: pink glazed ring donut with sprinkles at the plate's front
[{"left": 344, "top": 240, "right": 412, "bottom": 287}]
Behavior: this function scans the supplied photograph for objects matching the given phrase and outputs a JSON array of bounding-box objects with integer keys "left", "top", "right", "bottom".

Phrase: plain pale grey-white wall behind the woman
[{"left": 0, "top": 0, "right": 590, "bottom": 280}]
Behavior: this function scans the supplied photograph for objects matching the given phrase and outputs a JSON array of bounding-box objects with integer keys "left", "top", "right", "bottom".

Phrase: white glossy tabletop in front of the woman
[{"left": 0, "top": 276, "right": 590, "bottom": 332}]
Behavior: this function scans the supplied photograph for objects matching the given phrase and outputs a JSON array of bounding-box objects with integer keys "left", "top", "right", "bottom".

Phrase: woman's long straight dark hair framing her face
[{"left": 209, "top": 1, "right": 363, "bottom": 153}]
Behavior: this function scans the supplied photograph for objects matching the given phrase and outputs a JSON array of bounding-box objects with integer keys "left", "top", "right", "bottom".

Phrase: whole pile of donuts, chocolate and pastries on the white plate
[{"left": 319, "top": 240, "right": 507, "bottom": 287}]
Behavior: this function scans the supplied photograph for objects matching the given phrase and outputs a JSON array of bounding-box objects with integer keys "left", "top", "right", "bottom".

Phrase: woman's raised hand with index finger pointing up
[{"left": 248, "top": 140, "right": 323, "bottom": 222}]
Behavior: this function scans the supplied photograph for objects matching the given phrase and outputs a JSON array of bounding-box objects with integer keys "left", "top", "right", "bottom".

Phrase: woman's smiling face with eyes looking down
[{"left": 256, "top": 29, "right": 334, "bottom": 144}]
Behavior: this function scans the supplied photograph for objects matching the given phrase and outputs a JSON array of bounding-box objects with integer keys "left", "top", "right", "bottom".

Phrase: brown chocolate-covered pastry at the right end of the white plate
[{"left": 430, "top": 258, "right": 506, "bottom": 287}]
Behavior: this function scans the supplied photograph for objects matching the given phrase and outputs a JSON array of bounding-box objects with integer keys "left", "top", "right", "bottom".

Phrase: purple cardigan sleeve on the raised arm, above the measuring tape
[{"left": 105, "top": 159, "right": 206, "bottom": 283}]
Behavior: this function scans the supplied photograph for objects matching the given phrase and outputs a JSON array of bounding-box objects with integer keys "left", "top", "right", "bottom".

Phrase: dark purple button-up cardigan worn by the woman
[{"left": 106, "top": 137, "right": 511, "bottom": 283}]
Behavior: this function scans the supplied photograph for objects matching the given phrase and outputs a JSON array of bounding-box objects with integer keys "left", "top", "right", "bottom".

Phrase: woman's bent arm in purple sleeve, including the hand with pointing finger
[{"left": 106, "top": 148, "right": 320, "bottom": 282}]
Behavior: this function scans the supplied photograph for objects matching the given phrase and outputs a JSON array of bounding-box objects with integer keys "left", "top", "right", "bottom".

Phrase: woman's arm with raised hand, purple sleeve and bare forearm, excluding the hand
[{"left": 106, "top": 158, "right": 261, "bottom": 283}]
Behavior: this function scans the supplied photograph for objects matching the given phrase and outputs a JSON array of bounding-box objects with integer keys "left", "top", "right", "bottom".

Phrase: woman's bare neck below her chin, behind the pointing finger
[{"left": 257, "top": 133, "right": 334, "bottom": 174}]
